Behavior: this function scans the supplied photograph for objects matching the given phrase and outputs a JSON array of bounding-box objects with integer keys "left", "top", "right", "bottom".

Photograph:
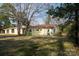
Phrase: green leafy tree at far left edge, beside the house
[{"left": 0, "top": 4, "right": 11, "bottom": 28}]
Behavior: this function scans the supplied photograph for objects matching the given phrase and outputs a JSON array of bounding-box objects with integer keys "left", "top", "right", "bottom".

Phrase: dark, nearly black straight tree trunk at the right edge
[{"left": 75, "top": 9, "right": 79, "bottom": 45}]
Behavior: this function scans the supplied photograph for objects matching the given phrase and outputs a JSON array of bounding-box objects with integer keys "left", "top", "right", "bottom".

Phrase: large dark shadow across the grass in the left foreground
[{"left": 0, "top": 39, "right": 54, "bottom": 56}]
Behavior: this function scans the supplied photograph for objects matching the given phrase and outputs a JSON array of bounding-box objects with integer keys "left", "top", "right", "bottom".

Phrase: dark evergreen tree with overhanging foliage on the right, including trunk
[{"left": 49, "top": 3, "right": 79, "bottom": 45}]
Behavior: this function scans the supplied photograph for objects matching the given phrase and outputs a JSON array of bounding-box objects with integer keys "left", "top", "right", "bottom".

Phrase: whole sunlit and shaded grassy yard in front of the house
[{"left": 0, "top": 36, "right": 79, "bottom": 56}]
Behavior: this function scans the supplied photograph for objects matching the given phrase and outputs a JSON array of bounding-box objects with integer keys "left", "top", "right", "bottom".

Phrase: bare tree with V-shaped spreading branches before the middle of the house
[{"left": 13, "top": 3, "right": 45, "bottom": 34}]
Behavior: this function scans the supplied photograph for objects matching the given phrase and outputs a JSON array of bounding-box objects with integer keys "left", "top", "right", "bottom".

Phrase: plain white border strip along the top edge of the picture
[{"left": 0, "top": 0, "right": 79, "bottom": 3}]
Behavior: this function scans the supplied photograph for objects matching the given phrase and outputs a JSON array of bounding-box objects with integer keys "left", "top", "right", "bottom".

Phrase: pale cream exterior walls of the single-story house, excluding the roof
[{"left": 4, "top": 27, "right": 58, "bottom": 36}]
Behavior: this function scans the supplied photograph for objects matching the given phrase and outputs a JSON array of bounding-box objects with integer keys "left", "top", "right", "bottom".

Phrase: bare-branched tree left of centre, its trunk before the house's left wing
[{"left": 0, "top": 3, "right": 23, "bottom": 35}]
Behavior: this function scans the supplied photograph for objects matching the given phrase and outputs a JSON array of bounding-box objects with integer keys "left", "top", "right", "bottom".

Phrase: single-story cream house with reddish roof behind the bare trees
[{"left": 0, "top": 24, "right": 58, "bottom": 35}]
